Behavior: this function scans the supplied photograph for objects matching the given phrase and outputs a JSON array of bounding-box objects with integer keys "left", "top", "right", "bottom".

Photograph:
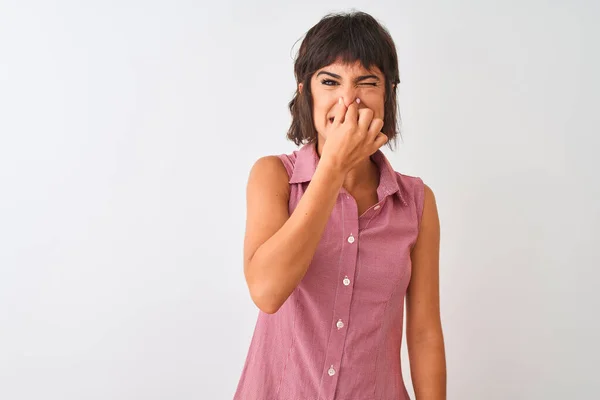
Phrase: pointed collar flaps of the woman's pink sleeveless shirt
[{"left": 289, "top": 143, "right": 406, "bottom": 204}]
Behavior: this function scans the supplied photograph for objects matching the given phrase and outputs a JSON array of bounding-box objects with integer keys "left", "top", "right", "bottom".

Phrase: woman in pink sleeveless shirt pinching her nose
[{"left": 235, "top": 12, "right": 446, "bottom": 400}]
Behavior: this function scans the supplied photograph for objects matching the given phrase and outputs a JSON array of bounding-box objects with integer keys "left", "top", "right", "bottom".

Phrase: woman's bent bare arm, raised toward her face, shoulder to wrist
[{"left": 244, "top": 156, "right": 345, "bottom": 314}]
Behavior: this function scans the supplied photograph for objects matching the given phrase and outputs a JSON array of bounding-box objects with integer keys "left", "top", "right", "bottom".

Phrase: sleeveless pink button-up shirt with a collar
[{"left": 234, "top": 144, "right": 424, "bottom": 400}]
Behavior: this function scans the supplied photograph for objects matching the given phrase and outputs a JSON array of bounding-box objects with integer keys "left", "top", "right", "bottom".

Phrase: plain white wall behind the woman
[{"left": 0, "top": 0, "right": 600, "bottom": 400}]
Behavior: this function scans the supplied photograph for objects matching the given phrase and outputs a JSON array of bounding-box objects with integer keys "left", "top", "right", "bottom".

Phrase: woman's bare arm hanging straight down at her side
[{"left": 406, "top": 185, "right": 446, "bottom": 400}]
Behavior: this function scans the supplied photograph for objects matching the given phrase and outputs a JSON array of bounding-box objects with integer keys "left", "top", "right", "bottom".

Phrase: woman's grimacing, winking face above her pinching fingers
[{"left": 300, "top": 61, "right": 385, "bottom": 139}]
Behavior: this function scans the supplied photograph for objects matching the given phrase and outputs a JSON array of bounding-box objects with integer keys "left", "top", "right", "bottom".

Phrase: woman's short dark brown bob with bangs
[{"left": 287, "top": 11, "right": 400, "bottom": 149}]
